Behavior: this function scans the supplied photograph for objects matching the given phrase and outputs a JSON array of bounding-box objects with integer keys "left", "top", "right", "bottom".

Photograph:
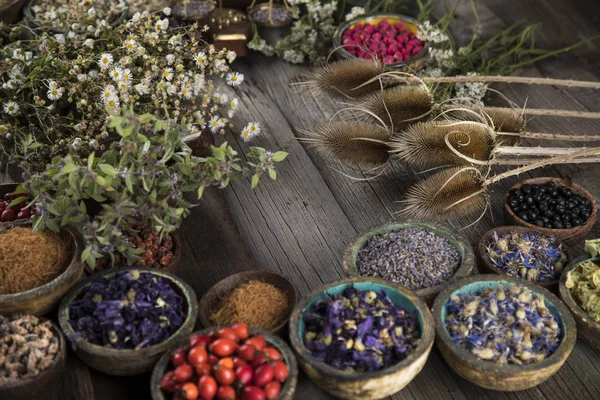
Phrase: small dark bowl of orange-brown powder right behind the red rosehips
[{"left": 198, "top": 270, "right": 299, "bottom": 336}]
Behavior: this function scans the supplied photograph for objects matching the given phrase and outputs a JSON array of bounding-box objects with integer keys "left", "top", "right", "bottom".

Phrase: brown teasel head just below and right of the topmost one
[{"left": 361, "top": 85, "right": 433, "bottom": 132}]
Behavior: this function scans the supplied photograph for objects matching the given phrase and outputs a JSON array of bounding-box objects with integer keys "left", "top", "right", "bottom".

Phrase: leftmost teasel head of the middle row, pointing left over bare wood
[{"left": 299, "top": 121, "right": 392, "bottom": 166}]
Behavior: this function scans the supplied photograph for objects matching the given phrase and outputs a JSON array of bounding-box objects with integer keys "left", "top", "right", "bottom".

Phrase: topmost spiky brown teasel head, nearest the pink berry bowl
[{"left": 312, "top": 59, "right": 385, "bottom": 98}]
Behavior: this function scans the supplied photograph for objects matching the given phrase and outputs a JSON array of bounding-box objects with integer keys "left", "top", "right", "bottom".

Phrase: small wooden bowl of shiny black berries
[{"left": 504, "top": 178, "right": 598, "bottom": 243}]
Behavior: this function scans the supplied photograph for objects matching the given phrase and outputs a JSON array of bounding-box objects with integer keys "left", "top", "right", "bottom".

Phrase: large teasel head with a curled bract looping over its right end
[{"left": 390, "top": 121, "right": 494, "bottom": 168}]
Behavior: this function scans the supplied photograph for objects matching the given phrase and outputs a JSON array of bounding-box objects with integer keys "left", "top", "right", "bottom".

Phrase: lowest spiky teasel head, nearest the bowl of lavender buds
[{"left": 400, "top": 167, "right": 488, "bottom": 220}]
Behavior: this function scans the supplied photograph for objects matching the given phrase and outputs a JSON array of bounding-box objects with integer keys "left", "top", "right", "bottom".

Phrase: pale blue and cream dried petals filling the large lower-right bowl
[{"left": 445, "top": 285, "right": 561, "bottom": 365}]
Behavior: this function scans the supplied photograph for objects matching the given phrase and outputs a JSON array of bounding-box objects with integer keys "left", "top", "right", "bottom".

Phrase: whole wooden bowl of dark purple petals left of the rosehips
[{"left": 58, "top": 268, "right": 198, "bottom": 376}]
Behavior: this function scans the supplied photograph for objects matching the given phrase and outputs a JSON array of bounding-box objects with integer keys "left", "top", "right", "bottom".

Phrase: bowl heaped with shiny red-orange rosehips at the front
[{"left": 151, "top": 323, "right": 298, "bottom": 400}]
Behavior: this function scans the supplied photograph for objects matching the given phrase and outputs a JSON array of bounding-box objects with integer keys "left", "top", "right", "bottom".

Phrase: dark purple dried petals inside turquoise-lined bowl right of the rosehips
[{"left": 303, "top": 286, "right": 420, "bottom": 372}]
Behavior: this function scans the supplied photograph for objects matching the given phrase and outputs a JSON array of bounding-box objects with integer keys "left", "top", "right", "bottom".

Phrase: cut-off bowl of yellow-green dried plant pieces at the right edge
[{"left": 559, "top": 257, "right": 600, "bottom": 350}]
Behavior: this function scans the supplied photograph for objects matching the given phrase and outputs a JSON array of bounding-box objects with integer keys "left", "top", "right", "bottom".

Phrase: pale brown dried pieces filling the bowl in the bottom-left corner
[{"left": 0, "top": 314, "right": 59, "bottom": 385}]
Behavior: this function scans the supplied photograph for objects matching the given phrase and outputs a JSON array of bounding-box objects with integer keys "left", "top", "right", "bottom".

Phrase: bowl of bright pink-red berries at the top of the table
[{"left": 333, "top": 14, "right": 429, "bottom": 70}]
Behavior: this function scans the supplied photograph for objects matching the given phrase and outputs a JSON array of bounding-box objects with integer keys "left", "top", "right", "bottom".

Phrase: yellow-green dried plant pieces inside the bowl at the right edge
[{"left": 565, "top": 261, "right": 600, "bottom": 322}]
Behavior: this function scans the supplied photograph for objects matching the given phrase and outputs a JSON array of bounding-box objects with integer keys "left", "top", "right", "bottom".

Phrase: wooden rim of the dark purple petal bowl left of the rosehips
[{"left": 58, "top": 267, "right": 198, "bottom": 357}]
